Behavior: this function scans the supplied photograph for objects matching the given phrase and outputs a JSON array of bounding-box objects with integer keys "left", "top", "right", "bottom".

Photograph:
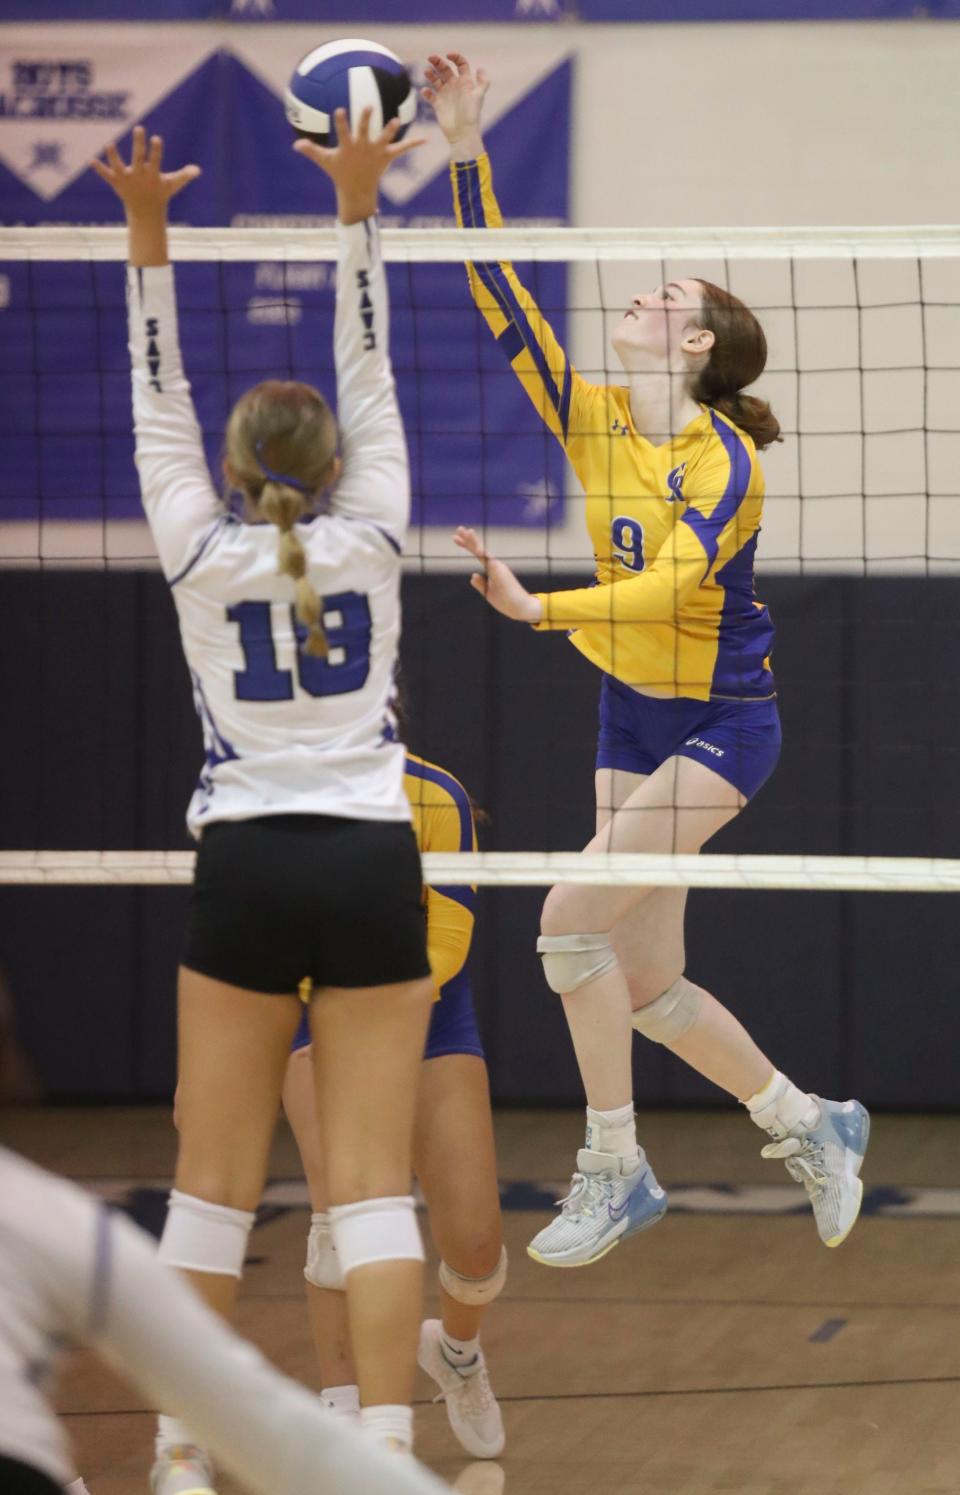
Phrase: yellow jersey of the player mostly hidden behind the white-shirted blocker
[{"left": 404, "top": 752, "right": 477, "bottom": 999}]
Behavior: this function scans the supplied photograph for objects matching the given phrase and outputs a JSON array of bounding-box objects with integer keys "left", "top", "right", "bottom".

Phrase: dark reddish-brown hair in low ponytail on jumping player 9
[{"left": 691, "top": 281, "right": 784, "bottom": 451}]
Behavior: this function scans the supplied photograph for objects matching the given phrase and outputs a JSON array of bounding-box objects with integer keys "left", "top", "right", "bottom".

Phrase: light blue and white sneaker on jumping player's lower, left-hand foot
[{"left": 526, "top": 1147, "right": 667, "bottom": 1266}]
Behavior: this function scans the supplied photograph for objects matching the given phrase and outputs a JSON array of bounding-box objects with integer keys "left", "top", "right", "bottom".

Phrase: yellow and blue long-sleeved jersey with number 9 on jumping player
[{"left": 450, "top": 155, "right": 775, "bottom": 701}]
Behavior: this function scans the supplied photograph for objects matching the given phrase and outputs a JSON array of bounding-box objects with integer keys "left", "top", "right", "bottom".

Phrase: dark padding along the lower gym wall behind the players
[{"left": 0, "top": 571, "right": 960, "bottom": 1108}]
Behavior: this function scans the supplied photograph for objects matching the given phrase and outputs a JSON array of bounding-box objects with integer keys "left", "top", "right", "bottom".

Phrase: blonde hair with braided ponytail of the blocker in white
[{"left": 226, "top": 380, "right": 336, "bottom": 658}]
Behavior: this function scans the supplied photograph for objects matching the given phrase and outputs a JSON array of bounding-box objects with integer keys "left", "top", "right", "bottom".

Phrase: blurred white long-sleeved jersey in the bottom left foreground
[{"left": 0, "top": 1148, "right": 447, "bottom": 1495}]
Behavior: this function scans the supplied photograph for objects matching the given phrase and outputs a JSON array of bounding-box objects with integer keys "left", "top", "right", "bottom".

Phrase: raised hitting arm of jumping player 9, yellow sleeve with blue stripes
[{"left": 423, "top": 52, "right": 601, "bottom": 457}]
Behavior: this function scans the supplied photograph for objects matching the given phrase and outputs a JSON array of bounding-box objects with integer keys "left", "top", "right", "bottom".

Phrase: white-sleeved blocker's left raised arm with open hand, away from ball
[{"left": 93, "top": 126, "right": 223, "bottom": 582}]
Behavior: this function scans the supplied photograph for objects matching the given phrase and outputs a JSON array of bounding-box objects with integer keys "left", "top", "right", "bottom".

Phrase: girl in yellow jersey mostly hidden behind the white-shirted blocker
[{"left": 284, "top": 752, "right": 507, "bottom": 1459}]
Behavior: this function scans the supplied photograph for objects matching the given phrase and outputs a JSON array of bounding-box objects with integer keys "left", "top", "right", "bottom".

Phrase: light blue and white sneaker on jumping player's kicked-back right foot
[{"left": 761, "top": 1096, "right": 870, "bottom": 1245}]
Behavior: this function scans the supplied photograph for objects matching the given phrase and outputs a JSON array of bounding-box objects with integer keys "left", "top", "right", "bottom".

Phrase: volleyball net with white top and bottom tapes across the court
[{"left": 0, "top": 218, "right": 960, "bottom": 891}]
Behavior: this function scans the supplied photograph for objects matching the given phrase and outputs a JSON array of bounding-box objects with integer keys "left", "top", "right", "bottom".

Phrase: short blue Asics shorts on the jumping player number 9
[{"left": 597, "top": 674, "right": 781, "bottom": 800}]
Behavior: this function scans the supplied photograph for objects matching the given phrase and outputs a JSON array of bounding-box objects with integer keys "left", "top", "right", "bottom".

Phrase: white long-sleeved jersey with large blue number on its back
[{"left": 127, "top": 218, "right": 410, "bottom": 836}]
